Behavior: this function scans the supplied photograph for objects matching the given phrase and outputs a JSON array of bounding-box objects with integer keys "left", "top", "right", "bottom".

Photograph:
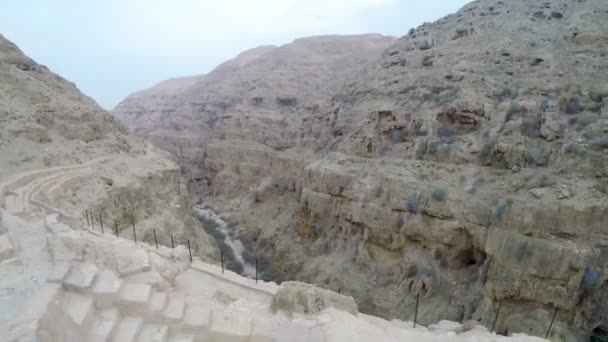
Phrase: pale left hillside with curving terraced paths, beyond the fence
[{"left": 0, "top": 36, "right": 218, "bottom": 258}]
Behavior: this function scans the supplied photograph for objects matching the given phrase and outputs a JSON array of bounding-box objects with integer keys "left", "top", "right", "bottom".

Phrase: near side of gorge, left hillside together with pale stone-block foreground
[{"left": 0, "top": 36, "right": 544, "bottom": 342}]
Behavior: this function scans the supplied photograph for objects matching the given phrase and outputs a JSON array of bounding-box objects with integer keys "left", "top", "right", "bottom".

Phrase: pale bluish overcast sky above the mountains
[{"left": 0, "top": 0, "right": 468, "bottom": 109}]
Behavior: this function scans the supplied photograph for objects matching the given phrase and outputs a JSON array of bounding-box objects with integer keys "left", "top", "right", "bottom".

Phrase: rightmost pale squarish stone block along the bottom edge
[{"left": 209, "top": 310, "right": 251, "bottom": 342}]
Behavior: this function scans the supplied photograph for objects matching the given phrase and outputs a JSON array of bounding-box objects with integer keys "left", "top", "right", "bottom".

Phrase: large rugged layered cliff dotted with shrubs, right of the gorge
[{"left": 113, "top": 0, "right": 608, "bottom": 341}]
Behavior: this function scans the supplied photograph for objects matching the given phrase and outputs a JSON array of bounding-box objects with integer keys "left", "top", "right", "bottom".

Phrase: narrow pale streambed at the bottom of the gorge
[{"left": 193, "top": 204, "right": 255, "bottom": 278}]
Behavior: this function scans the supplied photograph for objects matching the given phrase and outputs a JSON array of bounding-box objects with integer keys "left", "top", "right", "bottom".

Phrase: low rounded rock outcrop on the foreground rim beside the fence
[{"left": 272, "top": 281, "right": 359, "bottom": 315}]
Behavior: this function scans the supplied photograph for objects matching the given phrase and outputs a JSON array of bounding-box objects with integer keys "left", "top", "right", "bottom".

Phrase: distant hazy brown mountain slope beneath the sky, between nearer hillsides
[{"left": 112, "top": 34, "right": 394, "bottom": 154}]
